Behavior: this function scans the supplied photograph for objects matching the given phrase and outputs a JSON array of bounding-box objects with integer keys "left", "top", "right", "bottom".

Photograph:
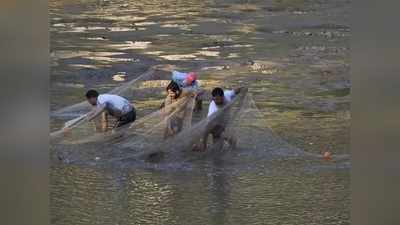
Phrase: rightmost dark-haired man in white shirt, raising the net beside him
[{"left": 201, "top": 87, "right": 240, "bottom": 150}]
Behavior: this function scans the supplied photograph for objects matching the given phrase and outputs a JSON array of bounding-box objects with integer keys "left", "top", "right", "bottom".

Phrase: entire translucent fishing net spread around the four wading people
[{"left": 51, "top": 62, "right": 350, "bottom": 168}]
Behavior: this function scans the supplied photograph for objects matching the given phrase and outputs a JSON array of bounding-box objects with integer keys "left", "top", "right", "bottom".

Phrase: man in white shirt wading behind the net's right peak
[{"left": 200, "top": 87, "right": 242, "bottom": 151}]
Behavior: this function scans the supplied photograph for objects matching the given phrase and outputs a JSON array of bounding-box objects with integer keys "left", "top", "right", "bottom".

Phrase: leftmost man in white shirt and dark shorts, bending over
[{"left": 86, "top": 90, "right": 136, "bottom": 127}]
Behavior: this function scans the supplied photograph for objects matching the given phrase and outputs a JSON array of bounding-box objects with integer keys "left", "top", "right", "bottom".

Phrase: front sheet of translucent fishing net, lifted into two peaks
[{"left": 52, "top": 85, "right": 303, "bottom": 168}]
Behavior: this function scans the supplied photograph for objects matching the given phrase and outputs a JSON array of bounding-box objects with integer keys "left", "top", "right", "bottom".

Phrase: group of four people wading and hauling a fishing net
[{"left": 86, "top": 70, "right": 241, "bottom": 150}]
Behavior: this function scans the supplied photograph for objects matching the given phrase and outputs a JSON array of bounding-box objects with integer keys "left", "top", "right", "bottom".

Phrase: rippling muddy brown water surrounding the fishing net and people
[{"left": 49, "top": 0, "right": 350, "bottom": 224}]
